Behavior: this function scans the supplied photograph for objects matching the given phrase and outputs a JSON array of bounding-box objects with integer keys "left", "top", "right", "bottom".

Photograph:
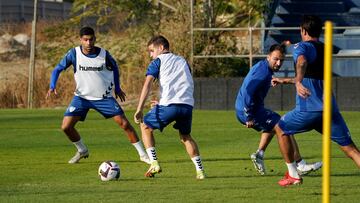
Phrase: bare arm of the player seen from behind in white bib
[{"left": 134, "top": 75, "right": 154, "bottom": 124}]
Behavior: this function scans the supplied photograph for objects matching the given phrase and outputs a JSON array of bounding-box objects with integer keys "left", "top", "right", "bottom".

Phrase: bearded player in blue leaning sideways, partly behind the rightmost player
[{"left": 235, "top": 44, "right": 322, "bottom": 175}]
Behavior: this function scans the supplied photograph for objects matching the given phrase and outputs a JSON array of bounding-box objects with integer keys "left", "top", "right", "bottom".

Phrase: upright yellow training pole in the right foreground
[{"left": 322, "top": 21, "right": 332, "bottom": 203}]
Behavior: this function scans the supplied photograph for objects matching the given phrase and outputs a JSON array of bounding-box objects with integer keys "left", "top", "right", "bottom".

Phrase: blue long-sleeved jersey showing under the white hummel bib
[{"left": 50, "top": 47, "right": 120, "bottom": 93}]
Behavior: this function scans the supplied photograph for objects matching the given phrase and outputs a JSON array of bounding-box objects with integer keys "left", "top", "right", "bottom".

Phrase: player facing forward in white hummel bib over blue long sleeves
[{"left": 46, "top": 27, "right": 150, "bottom": 164}]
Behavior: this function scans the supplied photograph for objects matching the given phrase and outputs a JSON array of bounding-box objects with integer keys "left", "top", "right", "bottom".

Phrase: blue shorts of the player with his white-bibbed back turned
[{"left": 144, "top": 104, "right": 193, "bottom": 135}]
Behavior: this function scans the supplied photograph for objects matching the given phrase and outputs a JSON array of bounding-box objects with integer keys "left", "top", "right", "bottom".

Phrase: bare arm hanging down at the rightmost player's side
[{"left": 295, "top": 55, "right": 311, "bottom": 98}]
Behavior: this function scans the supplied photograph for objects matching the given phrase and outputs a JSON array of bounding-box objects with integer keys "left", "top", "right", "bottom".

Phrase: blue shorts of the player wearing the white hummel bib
[{"left": 64, "top": 96, "right": 124, "bottom": 121}]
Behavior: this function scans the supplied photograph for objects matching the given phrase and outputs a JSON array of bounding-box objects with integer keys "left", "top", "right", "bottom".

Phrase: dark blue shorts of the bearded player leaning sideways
[{"left": 236, "top": 108, "right": 280, "bottom": 132}]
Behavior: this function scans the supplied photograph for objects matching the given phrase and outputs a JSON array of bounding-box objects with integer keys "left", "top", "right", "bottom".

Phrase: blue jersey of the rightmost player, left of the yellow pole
[{"left": 293, "top": 42, "right": 324, "bottom": 111}]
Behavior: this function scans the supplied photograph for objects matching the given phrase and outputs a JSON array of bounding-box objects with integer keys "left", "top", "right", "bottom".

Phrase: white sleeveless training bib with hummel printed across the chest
[{"left": 74, "top": 47, "right": 114, "bottom": 100}]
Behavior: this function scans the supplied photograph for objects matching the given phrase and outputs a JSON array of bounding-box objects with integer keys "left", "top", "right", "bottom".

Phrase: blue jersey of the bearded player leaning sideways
[{"left": 235, "top": 59, "right": 273, "bottom": 121}]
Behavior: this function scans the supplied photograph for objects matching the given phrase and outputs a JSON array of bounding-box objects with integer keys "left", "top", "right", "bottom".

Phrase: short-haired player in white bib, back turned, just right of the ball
[{"left": 134, "top": 36, "right": 205, "bottom": 179}]
